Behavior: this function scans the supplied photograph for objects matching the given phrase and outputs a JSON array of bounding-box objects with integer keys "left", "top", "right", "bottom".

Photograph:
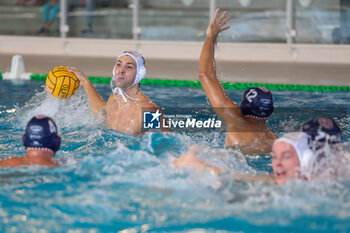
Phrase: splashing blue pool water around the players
[{"left": 0, "top": 80, "right": 350, "bottom": 232}]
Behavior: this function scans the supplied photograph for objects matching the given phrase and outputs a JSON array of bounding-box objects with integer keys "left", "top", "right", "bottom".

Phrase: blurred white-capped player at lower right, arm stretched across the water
[{"left": 174, "top": 121, "right": 346, "bottom": 184}]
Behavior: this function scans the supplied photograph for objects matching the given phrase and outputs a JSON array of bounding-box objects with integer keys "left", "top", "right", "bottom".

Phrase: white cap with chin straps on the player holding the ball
[{"left": 110, "top": 50, "right": 146, "bottom": 102}]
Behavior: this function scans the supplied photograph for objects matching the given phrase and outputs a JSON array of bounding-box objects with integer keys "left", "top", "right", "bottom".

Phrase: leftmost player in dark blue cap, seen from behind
[{"left": 0, "top": 115, "right": 61, "bottom": 167}]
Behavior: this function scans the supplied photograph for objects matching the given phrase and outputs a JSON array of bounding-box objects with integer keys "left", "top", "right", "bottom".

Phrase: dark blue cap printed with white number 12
[{"left": 240, "top": 87, "right": 274, "bottom": 119}]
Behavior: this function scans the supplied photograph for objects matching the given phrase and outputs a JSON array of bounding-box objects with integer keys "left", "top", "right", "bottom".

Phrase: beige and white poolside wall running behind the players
[{"left": 0, "top": 36, "right": 350, "bottom": 86}]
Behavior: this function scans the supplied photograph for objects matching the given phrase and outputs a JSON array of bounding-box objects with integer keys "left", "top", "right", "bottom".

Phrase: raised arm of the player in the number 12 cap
[{"left": 199, "top": 9, "right": 237, "bottom": 108}]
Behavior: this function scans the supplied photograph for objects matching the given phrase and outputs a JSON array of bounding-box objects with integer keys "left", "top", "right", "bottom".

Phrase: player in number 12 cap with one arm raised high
[{"left": 199, "top": 9, "right": 277, "bottom": 154}]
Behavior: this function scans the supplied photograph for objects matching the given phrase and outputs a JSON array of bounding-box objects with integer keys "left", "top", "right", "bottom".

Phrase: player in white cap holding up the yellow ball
[{"left": 67, "top": 51, "right": 159, "bottom": 135}]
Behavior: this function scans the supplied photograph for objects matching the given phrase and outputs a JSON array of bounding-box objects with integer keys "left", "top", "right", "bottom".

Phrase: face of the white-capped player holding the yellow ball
[{"left": 114, "top": 55, "right": 137, "bottom": 88}]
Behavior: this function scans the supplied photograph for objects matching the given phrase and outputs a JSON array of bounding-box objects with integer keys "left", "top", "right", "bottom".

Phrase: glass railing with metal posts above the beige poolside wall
[{"left": 0, "top": 0, "right": 350, "bottom": 43}]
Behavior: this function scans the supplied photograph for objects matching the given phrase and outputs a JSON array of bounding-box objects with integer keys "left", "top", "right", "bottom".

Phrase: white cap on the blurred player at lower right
[{"left": 273, "top": 132, "right": 314, "bottom": 172}]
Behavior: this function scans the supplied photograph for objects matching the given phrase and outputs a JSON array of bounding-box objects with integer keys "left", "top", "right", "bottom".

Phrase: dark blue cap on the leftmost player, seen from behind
[{"left": 23, "top": 115, "right": 61, "bottom": 152}]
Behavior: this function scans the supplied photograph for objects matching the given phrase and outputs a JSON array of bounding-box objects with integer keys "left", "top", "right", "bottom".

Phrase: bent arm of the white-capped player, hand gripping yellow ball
[{"left": 67, "top": 67, "right": 106, "bottom": 117}]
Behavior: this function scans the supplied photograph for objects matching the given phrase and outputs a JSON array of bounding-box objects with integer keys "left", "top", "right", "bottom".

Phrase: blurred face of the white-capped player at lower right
[{"left": 271, "top": 142, "right": 300, "bottom": 184}]
